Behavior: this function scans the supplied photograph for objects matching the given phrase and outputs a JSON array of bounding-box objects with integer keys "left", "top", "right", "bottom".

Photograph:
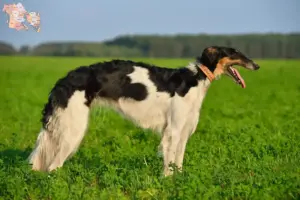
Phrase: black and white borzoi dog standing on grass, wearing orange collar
[{"left": 28, "top": 46, "right": 260, "bottom": 176}]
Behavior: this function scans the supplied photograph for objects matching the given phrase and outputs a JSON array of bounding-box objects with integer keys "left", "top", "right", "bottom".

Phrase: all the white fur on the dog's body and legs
[{"left": 30, "top": 64, "right": 210, "bottom": 176}]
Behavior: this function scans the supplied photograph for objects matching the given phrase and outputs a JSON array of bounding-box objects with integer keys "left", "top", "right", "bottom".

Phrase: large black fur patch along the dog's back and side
[{"left": 42, "top": 60, "right": 205, "bottom": 128}]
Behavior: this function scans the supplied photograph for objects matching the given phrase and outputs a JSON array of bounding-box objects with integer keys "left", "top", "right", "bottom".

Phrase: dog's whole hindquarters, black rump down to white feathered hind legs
[{"left": 29, "top": 66, "right": 98, "bottom": 171}]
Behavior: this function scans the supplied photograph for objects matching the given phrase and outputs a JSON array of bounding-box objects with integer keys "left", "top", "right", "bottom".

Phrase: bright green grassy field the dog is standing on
[{"left": 0, "top": 57, "right": 300, "bottom": 200}]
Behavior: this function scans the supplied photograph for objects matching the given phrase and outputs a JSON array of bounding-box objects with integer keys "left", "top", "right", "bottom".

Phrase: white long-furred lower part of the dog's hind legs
[{"left": 30, "top": 91, "right": 89, "bottom": 171}]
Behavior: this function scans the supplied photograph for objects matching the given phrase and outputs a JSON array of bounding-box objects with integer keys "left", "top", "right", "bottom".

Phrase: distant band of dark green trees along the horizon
[{"left": 0, "top": 33, "right": 300, "bottom": 58}]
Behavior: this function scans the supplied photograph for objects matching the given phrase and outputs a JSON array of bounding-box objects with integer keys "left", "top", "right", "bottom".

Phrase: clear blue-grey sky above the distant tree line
[{"left": 0, "top": 0, "right": 300, "bottom": 47}]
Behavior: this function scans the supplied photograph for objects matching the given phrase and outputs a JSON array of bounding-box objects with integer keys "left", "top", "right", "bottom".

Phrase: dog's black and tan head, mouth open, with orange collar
[{"left": 197, "top": 46, "right": 260, "bottom": 88}]
